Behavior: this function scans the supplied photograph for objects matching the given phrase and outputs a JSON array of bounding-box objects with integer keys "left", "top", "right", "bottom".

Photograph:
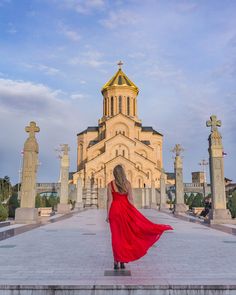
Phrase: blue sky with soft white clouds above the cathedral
[{"left": 0, "top": 0, "right": 236, "bottom": 183}]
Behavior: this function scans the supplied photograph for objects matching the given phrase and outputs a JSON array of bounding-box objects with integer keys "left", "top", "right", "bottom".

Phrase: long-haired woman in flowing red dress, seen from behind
[{"left": 106, "top": 165, "right": 173, "bottom": 269}]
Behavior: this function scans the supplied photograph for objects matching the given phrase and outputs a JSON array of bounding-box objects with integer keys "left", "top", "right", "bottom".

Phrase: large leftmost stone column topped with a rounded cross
[{"left": 15, "top": 122, "right": 40, "bottom": 223}]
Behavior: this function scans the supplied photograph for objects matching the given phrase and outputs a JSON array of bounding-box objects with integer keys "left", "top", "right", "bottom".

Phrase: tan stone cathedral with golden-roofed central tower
[{"left": 73, "top": 62, "right": 163, "bottom": 188}]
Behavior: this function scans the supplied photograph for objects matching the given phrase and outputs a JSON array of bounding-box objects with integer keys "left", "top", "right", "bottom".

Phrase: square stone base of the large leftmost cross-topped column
[{"left": 15, "top": 208, "right": 39, "bottom": 224}]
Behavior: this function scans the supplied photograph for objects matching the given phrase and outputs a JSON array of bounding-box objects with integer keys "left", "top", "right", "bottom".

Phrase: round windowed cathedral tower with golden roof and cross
[{"left": 99, "top": 61, "right": 140, "bottom": 123}]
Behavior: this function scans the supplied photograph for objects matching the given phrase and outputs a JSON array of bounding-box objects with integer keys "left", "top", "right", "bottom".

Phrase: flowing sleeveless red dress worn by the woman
[{"left": 109, "top": 182, "right": 173, "bottom": 263}]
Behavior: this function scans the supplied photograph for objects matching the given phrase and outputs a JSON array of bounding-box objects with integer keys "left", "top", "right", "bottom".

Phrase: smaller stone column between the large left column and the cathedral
[{"left": 57, "top": 144, "right": 70, "bottom": 214}]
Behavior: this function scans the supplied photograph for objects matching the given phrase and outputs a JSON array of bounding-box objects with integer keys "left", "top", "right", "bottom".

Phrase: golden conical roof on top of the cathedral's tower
[{"left": 102, "top": 68, "right": 139, "bottom": 94}]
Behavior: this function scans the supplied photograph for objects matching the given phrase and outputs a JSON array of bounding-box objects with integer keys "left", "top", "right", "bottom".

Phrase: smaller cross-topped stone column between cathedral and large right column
[{"left": 173, "top": 144, "right": 188, "bottom": 213}]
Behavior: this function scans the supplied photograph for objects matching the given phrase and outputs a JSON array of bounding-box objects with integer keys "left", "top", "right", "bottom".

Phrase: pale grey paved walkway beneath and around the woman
[{"left": 0, "top": 209, "right": 236, "bottom": 285}]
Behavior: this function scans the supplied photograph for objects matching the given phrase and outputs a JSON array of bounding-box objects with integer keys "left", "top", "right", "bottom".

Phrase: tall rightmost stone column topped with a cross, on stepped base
[{"left": 206, "top": 115, "right": 236, "bottom": 224}]
